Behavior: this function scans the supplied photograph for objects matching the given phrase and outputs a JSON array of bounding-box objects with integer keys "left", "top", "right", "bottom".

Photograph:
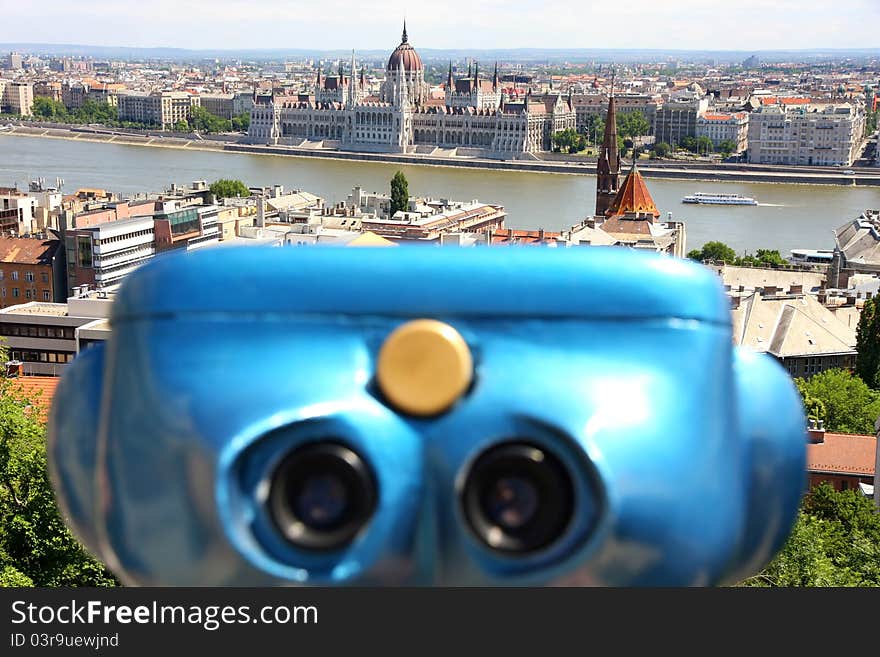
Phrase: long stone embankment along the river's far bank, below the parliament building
[{"left": 0, "top": 126, "right": 880, "bottom": 187}]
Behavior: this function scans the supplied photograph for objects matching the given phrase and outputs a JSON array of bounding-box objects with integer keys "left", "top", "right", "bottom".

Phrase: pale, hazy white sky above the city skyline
[{"left": 0, "top": 0, "right": 880, "bottom": 50}]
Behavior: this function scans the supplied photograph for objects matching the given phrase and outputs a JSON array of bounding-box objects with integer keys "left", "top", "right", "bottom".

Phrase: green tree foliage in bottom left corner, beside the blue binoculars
[{"left": 0, "top": 379, "right": 116, "bottom": 586}]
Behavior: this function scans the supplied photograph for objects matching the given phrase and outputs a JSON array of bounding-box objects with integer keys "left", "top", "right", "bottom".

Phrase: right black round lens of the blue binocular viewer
[{"left": 462, "top": 442, "right": 574, "bottom": 553}]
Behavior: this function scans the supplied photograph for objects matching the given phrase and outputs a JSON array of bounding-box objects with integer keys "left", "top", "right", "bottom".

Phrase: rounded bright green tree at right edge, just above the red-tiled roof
[{"left": 795, "top": 369, "right": 880, "bottom": 435}]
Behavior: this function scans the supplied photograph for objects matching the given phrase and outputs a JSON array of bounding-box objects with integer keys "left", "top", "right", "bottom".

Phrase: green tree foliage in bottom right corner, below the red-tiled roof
[{"left": 744, "top": 483, "right": 880, "bottom": 586}]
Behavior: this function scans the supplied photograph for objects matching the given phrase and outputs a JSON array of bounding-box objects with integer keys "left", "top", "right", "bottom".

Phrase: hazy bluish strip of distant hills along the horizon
[{"left": 0, "top": 43, "right": 880, "bottom": 63}]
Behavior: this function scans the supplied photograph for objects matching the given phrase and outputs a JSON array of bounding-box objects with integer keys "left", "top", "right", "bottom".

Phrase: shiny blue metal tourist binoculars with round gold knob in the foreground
[{"left": 49, "top": 247, "right": 805, "bottom": 586}]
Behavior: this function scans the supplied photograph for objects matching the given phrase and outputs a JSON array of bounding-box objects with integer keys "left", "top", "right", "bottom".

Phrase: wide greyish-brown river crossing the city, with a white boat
[{"left": 0, "top": 135, "right": 880, "bottom": 255}]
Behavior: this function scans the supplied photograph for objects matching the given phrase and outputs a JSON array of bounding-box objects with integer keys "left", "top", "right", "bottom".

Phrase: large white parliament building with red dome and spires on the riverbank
[{"left": 248, "top": 27, "right": 576, "bottom": 157}]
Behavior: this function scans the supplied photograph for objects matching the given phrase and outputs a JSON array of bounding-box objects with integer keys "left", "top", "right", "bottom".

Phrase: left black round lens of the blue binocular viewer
[{"left": 269, "top": 442, "right": 377, "bottom": 550}]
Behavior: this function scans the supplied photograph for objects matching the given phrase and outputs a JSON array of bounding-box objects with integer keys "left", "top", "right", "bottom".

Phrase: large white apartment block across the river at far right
[{"left": 748, "top": 103, "right": 865, "bottom": 166}]
